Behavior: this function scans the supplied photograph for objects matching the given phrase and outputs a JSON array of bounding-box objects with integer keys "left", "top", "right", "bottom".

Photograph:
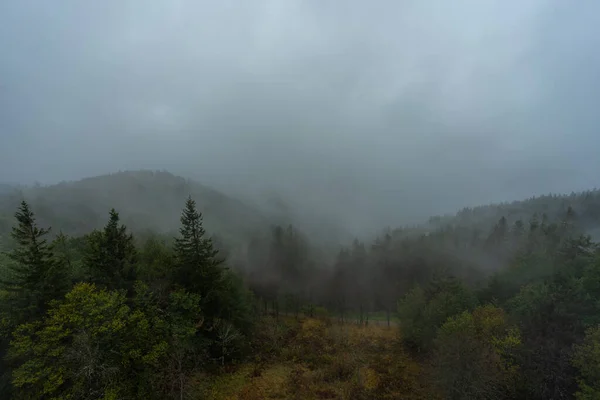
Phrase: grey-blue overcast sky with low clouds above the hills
[{"left": 0, "top": 0, "right": 600, "bottom": 231}]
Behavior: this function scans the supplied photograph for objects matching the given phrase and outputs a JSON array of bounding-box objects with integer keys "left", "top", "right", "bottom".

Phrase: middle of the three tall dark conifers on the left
[{"left": 85, "top": 208, "right": 137, "bottom": 289}]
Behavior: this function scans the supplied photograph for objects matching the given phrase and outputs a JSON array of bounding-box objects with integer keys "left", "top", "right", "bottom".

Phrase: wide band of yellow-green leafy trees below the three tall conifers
[{"left": 9, "top": 283, "right": 203, "bottom": 399}]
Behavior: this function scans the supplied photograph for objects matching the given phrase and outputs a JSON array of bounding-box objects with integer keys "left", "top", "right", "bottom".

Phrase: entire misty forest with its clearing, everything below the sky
[{"left": 0, "top": 176, "right": 600, "bottom": 400}]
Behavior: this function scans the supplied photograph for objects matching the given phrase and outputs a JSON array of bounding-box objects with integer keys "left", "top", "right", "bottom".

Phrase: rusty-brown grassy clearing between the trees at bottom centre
[{"left": 197, "top": 318, "right": 431, "bottom": 400}]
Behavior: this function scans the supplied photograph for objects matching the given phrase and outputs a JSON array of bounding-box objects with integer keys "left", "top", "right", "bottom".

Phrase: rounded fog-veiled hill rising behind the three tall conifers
[{"left": 0, "top": 171, "right": 268, "bottom": 248}]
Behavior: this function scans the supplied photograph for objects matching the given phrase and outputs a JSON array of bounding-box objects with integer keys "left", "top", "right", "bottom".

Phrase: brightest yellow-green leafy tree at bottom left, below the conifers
[{"left": 9, "top": 284, "right": 130, "bottom": 398}]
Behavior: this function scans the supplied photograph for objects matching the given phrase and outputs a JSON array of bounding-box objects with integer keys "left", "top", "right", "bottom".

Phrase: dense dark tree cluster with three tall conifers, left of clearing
[{"left": 1, "top": 198, "right": 254, "bottom": 399}]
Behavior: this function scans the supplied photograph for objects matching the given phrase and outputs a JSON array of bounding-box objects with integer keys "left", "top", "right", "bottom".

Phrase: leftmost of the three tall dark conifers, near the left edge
[{"left": 2, "top": 201, "right": 68, "bottom": 314}]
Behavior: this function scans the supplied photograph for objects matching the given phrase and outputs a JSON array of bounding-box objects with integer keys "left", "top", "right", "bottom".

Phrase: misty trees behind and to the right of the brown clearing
[{"left": 240, "top": 205, "right": 600, "bottom": 399}]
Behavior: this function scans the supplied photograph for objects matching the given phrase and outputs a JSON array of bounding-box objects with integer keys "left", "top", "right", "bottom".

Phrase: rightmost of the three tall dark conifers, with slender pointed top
[{"left": 175, "top": 197, "right": 223, "bottom": 301}]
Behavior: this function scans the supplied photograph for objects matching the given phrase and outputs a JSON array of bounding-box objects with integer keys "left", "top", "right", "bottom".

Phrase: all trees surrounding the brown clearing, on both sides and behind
[{"left": 0, "top": 190, "right": 600, "bottom": 399}]
